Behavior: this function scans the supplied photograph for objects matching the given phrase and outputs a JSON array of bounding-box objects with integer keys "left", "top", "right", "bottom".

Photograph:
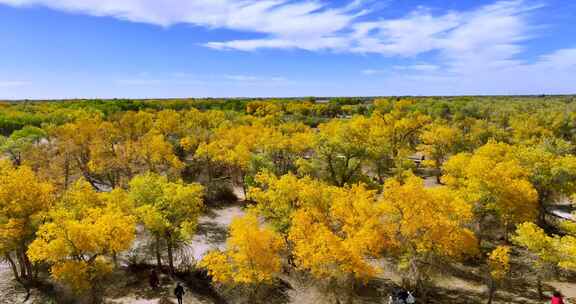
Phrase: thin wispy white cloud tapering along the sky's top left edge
[{"left": 0, "top": 0, "right": 363, "bottom": 37}]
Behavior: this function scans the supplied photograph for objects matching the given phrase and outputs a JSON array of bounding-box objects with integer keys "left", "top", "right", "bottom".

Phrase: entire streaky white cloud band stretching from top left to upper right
[{"left": 0, "top": 0, "right": 537, "bottom": 63}]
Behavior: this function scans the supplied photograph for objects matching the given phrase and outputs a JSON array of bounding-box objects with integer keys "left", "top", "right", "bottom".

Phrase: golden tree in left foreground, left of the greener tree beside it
[{"left": 28, "top": 181, "right": 136, "bottom": 296}]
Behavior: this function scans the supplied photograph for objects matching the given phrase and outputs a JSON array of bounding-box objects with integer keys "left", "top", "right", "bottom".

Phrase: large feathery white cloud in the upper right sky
[{"left": 206, "top": 0, "right": 540, "bottom": 63}]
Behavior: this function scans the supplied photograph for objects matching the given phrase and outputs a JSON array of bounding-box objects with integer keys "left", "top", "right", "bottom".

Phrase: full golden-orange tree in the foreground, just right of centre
[{"left": 380, "top": 175, "right": 477, "bottom": 291}]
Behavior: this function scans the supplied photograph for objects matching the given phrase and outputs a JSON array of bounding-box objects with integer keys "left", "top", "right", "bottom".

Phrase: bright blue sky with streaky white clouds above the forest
[{"left": 0, "top": 0, "right": 576, "bottom": 99}]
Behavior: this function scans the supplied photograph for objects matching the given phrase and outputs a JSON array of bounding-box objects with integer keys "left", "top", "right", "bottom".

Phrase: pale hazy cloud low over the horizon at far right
[{"left": 364, "top": 48, "right": 576, "bottom": 95}]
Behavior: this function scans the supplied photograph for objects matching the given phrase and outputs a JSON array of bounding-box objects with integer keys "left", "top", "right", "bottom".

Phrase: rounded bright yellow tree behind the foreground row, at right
[{"left": 442, "top": 142, "right": 538, "bottom": 237}]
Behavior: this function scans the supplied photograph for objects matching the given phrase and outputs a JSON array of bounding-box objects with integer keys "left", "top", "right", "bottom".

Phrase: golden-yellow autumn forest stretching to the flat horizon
[{"left": 0, "top": 96, "right": 576, "bottom": 304}]
